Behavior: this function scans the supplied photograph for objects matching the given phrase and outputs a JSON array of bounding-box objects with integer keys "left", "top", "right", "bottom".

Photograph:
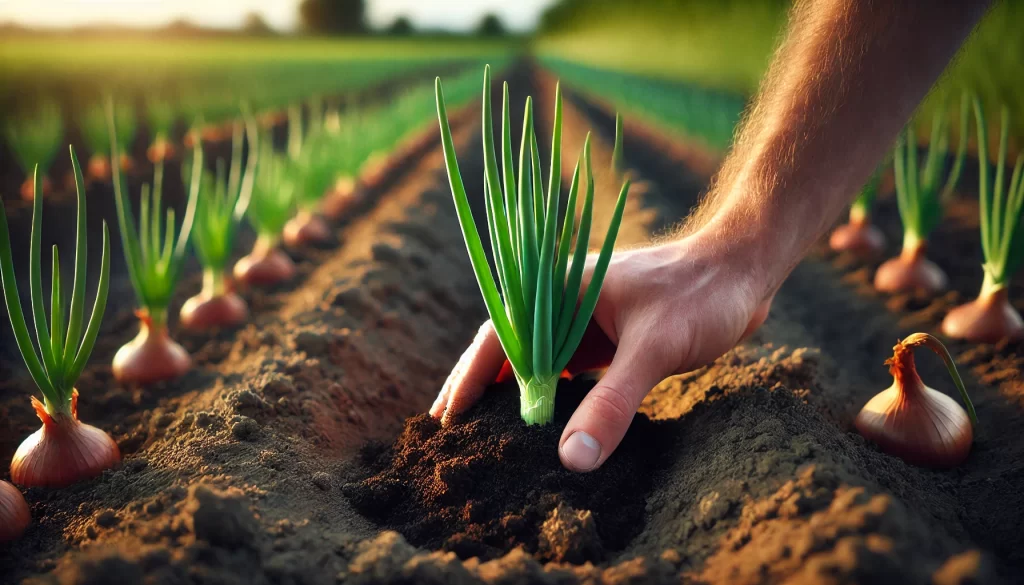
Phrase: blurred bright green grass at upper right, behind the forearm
[{"left": 535, "top": 0, "right": 1024, "bottom": 139}]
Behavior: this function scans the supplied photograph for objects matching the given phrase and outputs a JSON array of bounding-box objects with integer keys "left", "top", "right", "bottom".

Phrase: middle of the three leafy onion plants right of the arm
[{"left": 874, "top": 96, "right": 971, "bottom": 293}]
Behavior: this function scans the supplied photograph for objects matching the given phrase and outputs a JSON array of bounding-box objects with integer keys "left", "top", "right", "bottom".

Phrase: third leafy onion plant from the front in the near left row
[{"left": 180, "top": 120, "right": 259, "bottom": 331}]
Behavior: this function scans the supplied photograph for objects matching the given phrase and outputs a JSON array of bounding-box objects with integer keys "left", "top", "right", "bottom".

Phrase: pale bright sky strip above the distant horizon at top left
[{"left": 0, "top": 0, "right": 552, "bottom": 31}]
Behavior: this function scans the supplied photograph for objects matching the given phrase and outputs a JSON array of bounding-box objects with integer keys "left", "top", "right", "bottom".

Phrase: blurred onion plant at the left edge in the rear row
[{"left": 5, "top": 100, "right": 63, "bottom": 201}]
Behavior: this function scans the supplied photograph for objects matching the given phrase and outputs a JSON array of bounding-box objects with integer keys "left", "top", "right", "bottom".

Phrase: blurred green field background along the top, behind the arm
[{"left": 0, "top": 0, "right": 1024, "bottom": 198}]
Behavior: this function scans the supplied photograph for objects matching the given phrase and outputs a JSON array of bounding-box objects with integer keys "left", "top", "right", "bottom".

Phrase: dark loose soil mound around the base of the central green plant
[{"left": 343, "top": 379, "right": 668, "bottom": 563}]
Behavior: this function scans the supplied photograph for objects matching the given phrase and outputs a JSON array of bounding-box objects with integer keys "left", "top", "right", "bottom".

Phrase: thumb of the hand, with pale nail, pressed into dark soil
[{"left": 558, "top": 331, "right": 673, "bottom": 471}]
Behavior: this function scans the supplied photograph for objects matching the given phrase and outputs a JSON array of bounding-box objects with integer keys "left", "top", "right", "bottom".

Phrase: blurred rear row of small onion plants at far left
[{"left": 3, "top": 59, "right": 493, "bottom": 201}]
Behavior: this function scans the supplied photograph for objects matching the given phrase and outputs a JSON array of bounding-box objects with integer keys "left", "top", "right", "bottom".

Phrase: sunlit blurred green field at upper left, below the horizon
[{"left": 0, "top": 36, "right": 518, "bottom": 145}]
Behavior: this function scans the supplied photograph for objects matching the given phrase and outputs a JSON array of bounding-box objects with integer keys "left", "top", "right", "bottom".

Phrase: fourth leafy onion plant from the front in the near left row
[{"left": 233, "top": 140, "right": 296, "bottom": 286}]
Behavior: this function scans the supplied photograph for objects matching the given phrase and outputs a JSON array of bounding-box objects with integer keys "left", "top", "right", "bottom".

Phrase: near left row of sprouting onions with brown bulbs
[{"left": 0, "top": 65, "right": 491, "bottom": 540}]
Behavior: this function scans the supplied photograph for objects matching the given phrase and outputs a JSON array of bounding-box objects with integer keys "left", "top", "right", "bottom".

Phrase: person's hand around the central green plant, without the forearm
[{"left": 430, "top": 233, "right": 771, "bottom": 471}]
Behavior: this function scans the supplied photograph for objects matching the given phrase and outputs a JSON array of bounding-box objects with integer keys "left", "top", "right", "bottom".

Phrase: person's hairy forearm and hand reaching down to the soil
[{"left": 430, "top": 0, "right": 988, "bottom": 471}]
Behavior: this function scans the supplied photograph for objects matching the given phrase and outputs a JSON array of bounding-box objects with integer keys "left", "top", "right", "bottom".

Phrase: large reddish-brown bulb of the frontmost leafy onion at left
[{"left": 10, "top": 390, "right": 121, "bottom": 488}]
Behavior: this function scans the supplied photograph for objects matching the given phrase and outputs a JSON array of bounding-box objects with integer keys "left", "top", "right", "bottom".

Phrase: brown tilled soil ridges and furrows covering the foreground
[{"left": 0, "top": 64, "right": 1024, "bottom": 585}]
